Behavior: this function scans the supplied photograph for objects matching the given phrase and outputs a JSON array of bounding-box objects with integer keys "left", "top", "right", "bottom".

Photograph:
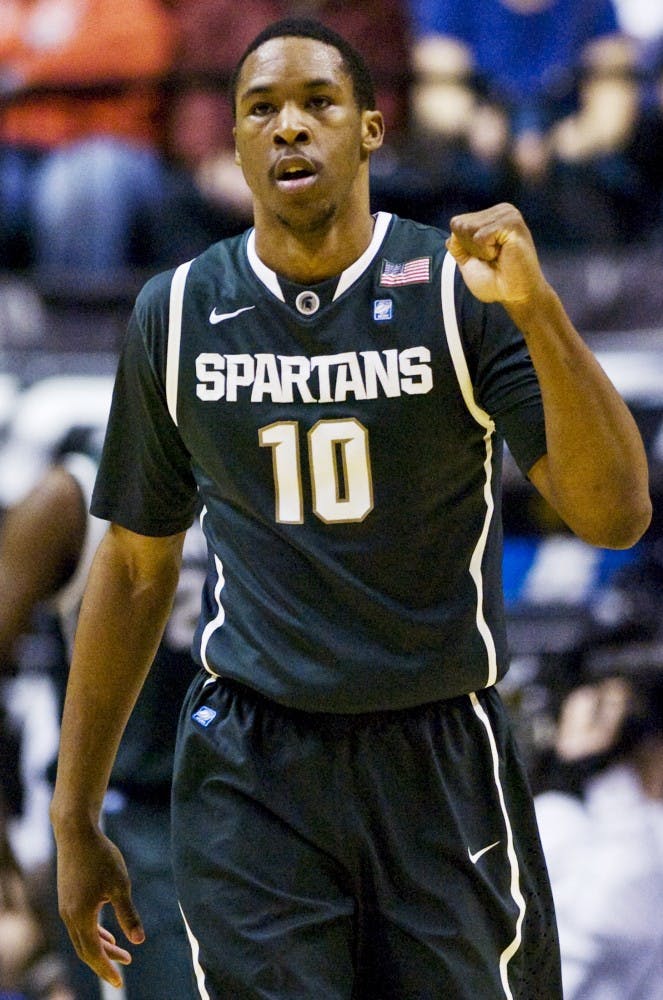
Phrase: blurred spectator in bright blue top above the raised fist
[{"left": 411, "top": 0, "right": 638, "bottom": 245}]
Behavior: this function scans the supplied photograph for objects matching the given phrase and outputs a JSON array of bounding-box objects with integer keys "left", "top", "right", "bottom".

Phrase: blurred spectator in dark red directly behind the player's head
[{"left": 162, "top": 0, "right": 410, "bottom": 249}]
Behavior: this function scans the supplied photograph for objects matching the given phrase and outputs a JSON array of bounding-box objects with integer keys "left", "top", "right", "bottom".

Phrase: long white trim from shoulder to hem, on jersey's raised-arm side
[{"left": 441, "top": 253, "right": 497, "bottom": 687}]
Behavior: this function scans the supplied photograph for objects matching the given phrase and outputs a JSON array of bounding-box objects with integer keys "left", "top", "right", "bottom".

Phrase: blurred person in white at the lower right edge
[{"left": 535, "top": 641, "right": 663, "bottom": 1000}]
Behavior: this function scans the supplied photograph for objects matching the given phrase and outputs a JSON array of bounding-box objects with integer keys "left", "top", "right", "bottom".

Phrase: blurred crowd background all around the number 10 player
[{"left": 0, "top": 0, "right": 663, "bottom": 1000}]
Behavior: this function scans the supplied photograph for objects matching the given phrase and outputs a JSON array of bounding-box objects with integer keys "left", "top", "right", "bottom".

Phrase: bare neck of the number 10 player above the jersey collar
[{"left": 255, "top": 207, "right": 375, "bottom": 284}]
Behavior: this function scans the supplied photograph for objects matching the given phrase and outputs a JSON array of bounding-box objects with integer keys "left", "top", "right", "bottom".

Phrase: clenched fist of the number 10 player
[{"left": 446, "top": 203, "right": 547, "bottom": 306}]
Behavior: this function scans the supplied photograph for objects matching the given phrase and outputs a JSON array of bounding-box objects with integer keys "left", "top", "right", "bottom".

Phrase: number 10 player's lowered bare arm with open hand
[{"left": 51, "top": 525, "right": 185, "bottom": 986}]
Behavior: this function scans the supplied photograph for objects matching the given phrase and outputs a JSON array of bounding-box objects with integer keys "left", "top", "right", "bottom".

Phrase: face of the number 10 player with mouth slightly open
[{"left": 235, "top": 37, "right": 383, "bottom": 231}]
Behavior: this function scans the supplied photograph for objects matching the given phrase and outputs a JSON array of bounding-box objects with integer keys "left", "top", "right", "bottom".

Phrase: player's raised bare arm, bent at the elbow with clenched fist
[{"left": 447, "top": 204, "right": 651, "bottom": 549}]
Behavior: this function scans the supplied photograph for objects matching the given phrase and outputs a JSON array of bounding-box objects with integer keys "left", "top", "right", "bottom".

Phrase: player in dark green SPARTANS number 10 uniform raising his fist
[{"left": 52, "top": 21, "right": 651, "bottom": 1000}]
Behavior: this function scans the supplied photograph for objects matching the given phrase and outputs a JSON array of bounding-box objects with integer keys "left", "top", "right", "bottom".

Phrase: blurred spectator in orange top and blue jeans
[{"left": 0, "top": 0, "right": 175, "bottom": 280}]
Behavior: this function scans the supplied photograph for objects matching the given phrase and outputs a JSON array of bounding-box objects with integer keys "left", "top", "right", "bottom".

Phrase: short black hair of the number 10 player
[{"left": 228, "top": 17, "right": 375, "bottom": 114}]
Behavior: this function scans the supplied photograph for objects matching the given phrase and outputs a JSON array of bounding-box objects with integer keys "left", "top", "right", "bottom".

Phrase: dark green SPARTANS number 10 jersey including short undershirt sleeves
[{"left": 93, "top": 213, "right": 545, "bottom": 712}]
